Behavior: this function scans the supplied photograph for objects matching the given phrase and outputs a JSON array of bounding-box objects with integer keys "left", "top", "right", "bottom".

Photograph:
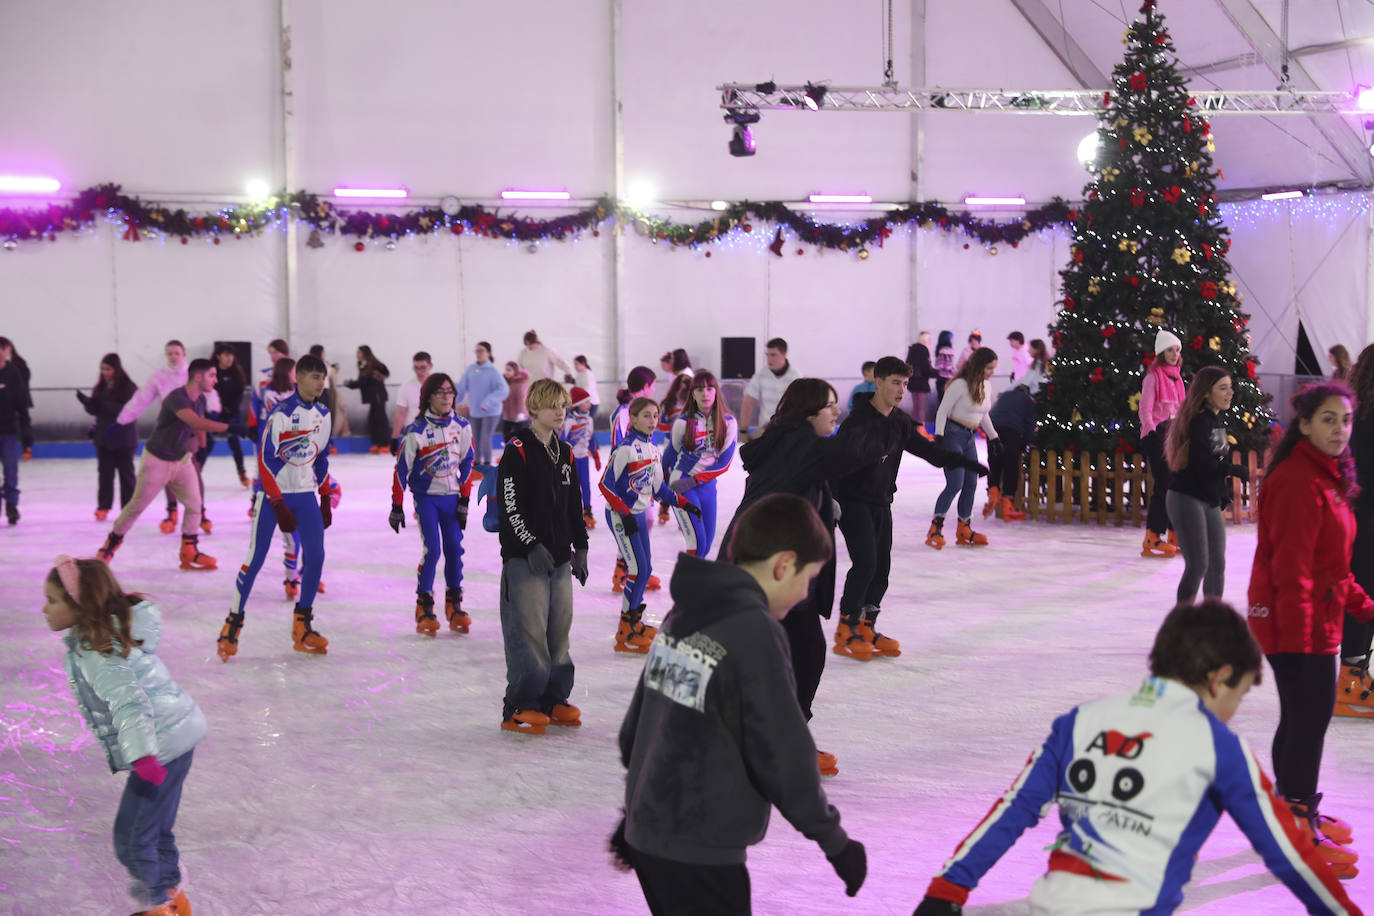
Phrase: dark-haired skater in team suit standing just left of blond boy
[{"left": 387, "top": 372, "right": 474, "bottom": 636}]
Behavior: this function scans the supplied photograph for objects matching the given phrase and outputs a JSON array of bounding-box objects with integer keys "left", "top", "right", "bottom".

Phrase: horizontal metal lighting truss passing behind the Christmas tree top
[{"left": 716, "top": 82, "right": 1367, "bottom": 115}]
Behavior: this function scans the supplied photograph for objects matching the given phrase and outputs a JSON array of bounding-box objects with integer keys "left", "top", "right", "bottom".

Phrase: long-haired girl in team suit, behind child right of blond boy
[{"left": 664, "top": 369, "right": 738, "bottom": 556}]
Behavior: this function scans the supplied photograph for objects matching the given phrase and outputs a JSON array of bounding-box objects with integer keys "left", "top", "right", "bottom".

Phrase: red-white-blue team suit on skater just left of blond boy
[{"left": 392, "top": 411, "right": 475, "bottom": 595}]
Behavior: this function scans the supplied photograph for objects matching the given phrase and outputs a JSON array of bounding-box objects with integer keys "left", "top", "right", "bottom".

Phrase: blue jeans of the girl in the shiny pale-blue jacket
[{"left": 114, "top": 751, "right": 194, "bottom": 906}]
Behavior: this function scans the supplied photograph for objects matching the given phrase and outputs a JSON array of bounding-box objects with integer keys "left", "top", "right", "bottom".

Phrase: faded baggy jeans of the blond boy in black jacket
[{"left": 500, "top": 558, "right": 573, "bottom": 718}]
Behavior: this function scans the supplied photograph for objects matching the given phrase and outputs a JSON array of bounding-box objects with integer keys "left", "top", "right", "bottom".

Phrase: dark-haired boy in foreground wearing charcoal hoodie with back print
[{"left": 611, "top": 493, "right": 867, "bottom": 916}]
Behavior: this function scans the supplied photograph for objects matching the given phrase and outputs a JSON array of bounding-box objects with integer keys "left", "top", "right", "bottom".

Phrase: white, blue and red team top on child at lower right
[{"left": 927, "top": 677, "right": 1359, "bottom": 916}]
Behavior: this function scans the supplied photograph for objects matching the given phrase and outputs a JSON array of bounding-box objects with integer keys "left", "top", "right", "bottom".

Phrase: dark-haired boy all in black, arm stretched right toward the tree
[{"left": 833, "top": 356, "right": 988, "bottom": 662}]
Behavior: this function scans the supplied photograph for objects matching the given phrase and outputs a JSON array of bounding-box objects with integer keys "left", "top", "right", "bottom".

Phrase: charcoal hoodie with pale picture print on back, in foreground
[{"left": 620, "top": 553, "right": 849, "bottom": 865}]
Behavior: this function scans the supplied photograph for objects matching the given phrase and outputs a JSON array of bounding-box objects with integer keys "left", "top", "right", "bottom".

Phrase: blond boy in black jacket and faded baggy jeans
[{"left": 496, "top": 379, "right": 587, "bottom": 735}]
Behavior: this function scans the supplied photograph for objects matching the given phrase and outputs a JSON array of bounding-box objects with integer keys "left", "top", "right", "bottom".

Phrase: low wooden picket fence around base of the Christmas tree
[{"left": 1016, "top": 449, "right": 1264, "bottom": 527}]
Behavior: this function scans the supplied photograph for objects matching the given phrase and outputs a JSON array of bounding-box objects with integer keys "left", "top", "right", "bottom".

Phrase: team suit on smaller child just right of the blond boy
[{"left": 600, "top": 428, "right": 686, "bottom": 611}]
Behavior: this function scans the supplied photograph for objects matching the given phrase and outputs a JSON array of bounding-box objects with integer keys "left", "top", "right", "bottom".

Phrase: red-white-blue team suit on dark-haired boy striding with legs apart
[{"left": 231, "top": 393, "right": 335, "bottom": 614}]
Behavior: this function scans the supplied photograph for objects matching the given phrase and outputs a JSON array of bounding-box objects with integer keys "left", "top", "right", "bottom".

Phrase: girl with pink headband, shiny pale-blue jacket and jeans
[{"left": 43, "top": 555, "right": 206, "bottom": 916}]
